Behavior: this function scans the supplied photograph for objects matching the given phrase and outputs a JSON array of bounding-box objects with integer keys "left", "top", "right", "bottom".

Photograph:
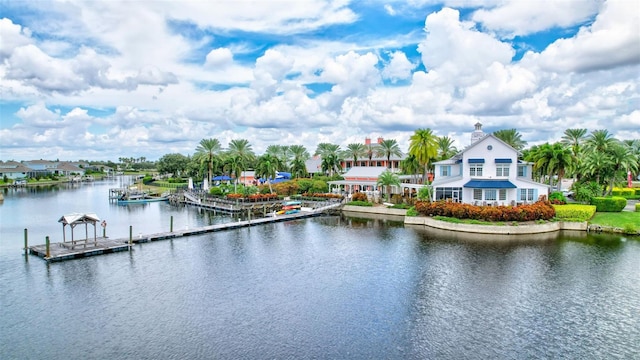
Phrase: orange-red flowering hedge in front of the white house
[{"left": 415, "top": 201, "right": 556, "bottom": 221}]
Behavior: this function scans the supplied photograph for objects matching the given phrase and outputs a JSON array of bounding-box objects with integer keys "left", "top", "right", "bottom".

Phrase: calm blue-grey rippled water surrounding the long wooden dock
[{"left": 0, "top": 179, "right": 640, "bottom": 359}]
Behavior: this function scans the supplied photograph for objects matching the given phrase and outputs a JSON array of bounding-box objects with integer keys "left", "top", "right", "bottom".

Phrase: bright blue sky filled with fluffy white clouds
[{"left": 0, "top": 0, "right": 640, "bottom": 161}]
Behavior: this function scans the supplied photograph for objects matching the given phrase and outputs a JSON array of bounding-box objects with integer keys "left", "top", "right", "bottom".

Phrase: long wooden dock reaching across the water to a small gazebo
[{"left": 29, "top": 203, "right": 342, "bottom": 262}]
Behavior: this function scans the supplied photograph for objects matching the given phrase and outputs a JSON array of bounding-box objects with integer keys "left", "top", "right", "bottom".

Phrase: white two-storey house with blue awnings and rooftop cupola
[{"left": 432, "top": 123, "right": 549, "bottom": 205}]
